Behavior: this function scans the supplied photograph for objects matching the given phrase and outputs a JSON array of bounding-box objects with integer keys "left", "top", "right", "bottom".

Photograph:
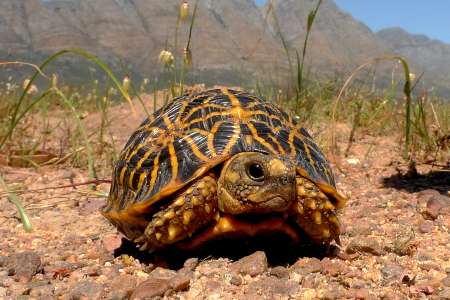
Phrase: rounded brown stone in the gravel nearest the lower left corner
[{"left": 7, "top": 251, "right": 42, "bottom": 282}]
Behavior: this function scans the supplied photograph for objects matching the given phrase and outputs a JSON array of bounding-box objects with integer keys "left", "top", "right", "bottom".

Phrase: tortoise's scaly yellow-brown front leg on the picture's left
[{"left": 136, "top": 174, "right": 217, "bottom": 250}]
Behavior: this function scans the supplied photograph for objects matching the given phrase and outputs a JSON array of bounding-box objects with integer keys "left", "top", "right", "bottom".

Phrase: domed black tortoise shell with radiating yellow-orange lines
[{"left": 103, "top": 88, "right": 337, "bottom": 226}]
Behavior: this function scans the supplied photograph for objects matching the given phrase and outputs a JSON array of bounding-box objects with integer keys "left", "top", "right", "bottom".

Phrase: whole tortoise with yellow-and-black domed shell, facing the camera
[{"left": 102, "top": 88, "right": 346, "bottom": 251}]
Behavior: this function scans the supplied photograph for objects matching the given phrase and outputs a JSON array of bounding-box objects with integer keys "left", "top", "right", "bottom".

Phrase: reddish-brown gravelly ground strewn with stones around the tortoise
[{"left": 0, "top": 100, "right": 450, "bottom": 299}]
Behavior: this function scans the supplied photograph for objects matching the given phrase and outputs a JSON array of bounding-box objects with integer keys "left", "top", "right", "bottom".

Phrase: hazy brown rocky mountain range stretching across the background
[{"left": 0, "top": 0, "right": 450, "bottom": 95}]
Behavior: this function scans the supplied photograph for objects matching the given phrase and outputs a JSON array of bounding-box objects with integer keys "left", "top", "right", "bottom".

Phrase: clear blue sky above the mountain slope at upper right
[{"left": 256, "top": 0, "right": 450, "bottom": 43}]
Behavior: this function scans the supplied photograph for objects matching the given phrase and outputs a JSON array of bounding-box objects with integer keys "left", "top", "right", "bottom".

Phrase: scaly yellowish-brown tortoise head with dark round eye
[{"left": 218, "top": 152, "right": 296, "bottom": 215}]
